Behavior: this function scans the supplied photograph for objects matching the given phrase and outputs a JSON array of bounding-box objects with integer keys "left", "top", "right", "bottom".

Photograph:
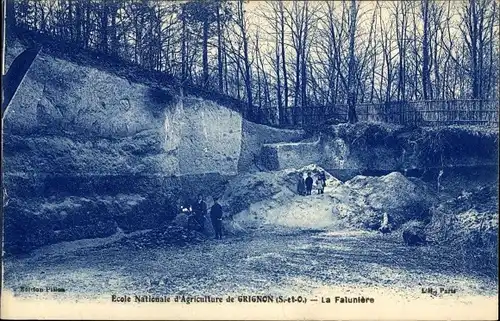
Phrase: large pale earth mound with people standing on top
[{"left": 221, "top": 164, "right": 433, "bottom": 232}]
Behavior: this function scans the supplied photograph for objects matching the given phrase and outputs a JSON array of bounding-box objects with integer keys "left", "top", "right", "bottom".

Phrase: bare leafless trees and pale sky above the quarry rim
[{"left": 7, "top": 0, "right": 499, "bottom": 125}]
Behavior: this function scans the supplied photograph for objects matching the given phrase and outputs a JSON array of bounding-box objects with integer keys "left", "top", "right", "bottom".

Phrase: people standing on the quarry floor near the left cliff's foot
[{"left": 188, "top": 194, "right": 222, "bottom": 240}]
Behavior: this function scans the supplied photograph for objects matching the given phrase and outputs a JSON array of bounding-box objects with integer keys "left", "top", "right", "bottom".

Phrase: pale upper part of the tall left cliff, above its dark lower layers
[{"left": 4, "top": 50, "right": 247, "bottom": 175}]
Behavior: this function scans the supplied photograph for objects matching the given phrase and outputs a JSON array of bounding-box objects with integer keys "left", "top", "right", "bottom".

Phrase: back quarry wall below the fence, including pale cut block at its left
[{"left": 261, "top": 123, "right": 498, "bottom": 174}]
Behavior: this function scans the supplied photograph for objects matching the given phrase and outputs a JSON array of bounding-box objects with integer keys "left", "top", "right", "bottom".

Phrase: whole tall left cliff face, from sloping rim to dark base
[{"left": 2, "top": 46, "right": 303, "bottom": 251}]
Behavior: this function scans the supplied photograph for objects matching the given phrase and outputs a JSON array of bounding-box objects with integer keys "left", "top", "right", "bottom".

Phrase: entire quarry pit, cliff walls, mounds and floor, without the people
[{"left": 2, "top": 45, "right": 498, "bottom": 300}]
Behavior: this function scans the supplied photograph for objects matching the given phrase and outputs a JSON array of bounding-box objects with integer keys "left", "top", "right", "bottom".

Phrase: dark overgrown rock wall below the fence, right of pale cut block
[{"left": 323, "top": 123, "right": 498, "bottom": 171}]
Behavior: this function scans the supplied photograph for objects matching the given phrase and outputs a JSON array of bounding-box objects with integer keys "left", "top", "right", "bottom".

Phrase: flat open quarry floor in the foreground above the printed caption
[{"left": 4, "top": 222, "right": 496, "bottom": 304}]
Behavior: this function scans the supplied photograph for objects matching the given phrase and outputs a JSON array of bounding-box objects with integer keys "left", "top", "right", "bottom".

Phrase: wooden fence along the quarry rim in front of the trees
[{"left": 260, "top": 99, "right": 499, "bottom": 127}]
